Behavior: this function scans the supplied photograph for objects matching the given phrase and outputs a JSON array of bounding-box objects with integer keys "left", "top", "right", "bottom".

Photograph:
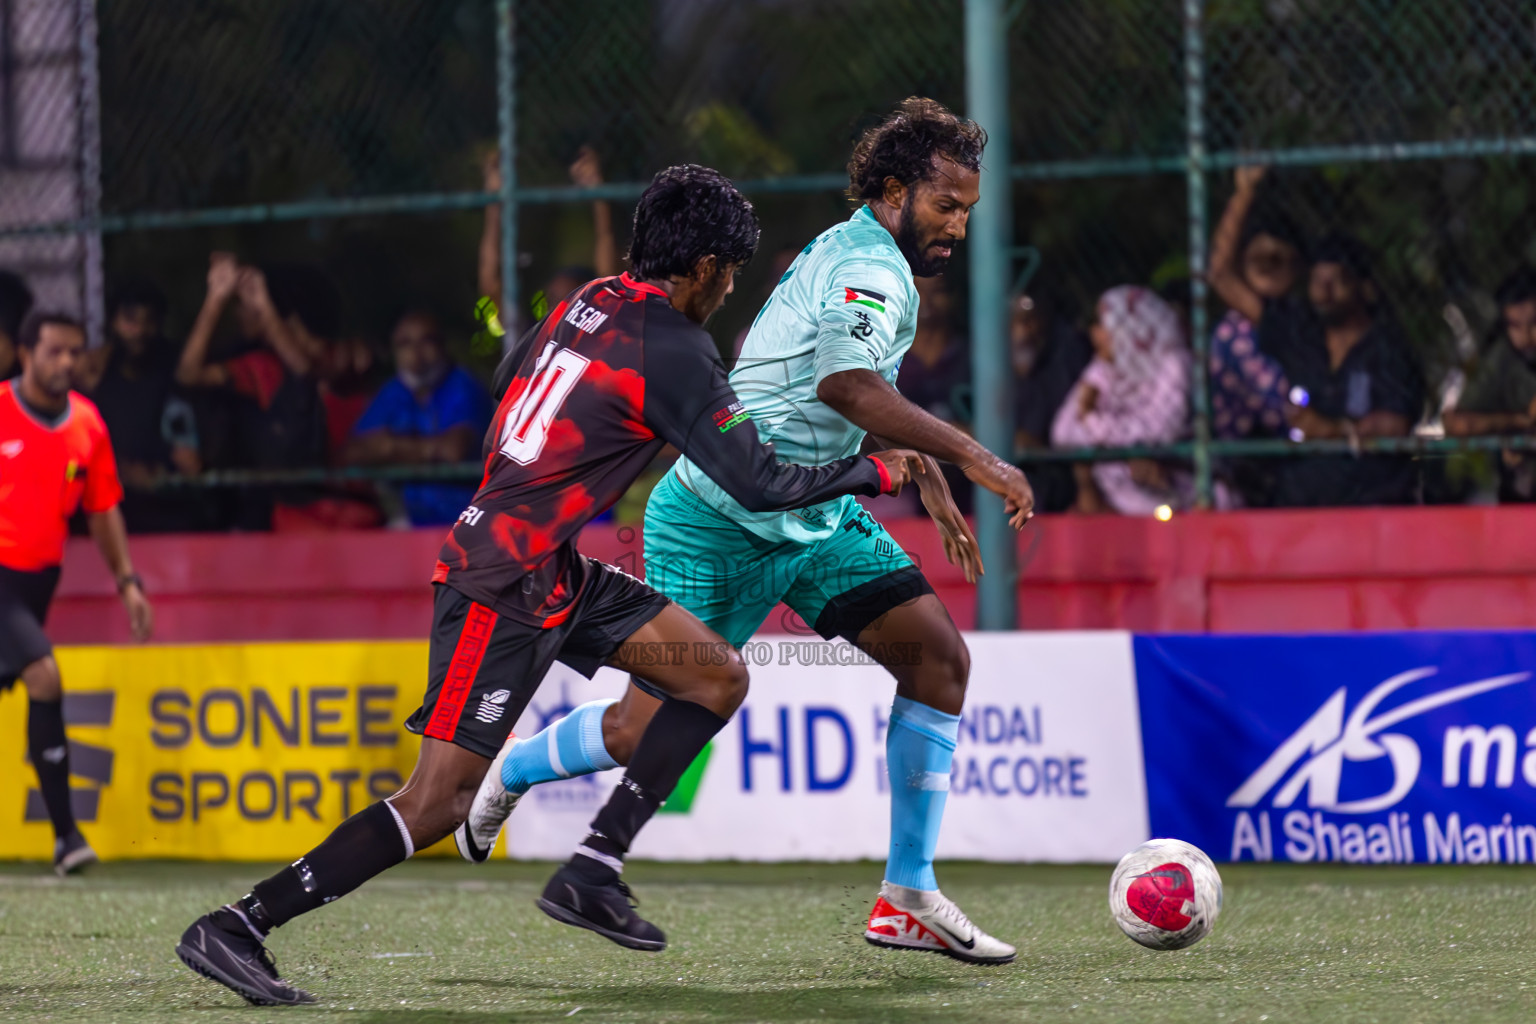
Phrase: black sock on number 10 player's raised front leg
[{"left": 571, "top": 700, "right": 725, "bottom": 875}]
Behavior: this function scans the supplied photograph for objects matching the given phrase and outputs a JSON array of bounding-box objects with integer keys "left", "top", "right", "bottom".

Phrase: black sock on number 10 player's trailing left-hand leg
[{"left": 225, "top": 800, "right": 416, "bottom": 935}]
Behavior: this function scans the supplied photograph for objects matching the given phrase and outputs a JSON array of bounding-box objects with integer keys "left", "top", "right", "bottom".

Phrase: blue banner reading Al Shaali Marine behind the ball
[{"left": 1134, "top": 633, "right": 1536, "bottom": 863}]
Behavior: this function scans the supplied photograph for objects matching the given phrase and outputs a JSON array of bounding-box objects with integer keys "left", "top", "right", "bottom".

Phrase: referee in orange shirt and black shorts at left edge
[{"left": 0, "top": 312, "right": 154, "bottom": 875}]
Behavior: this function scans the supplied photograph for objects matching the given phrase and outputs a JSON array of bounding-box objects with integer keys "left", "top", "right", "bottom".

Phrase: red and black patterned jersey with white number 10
[{"left": 432, "top": 273, "right": 889, "bottom": 625}]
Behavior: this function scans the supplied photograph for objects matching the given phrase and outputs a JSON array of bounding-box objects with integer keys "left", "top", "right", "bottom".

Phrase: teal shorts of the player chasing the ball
[{"left": 645, "top": 473, "right": 934, "bottom": 648}]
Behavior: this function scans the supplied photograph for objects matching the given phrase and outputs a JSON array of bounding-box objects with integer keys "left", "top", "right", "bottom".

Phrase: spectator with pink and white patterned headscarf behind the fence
[{"left": 1051, "top": 286, "right": 1193, "bottom": 516}]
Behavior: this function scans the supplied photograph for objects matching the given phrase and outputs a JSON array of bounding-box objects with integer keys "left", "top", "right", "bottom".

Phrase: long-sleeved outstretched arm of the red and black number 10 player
[{"left": 645, "top": 322, "right": 923, "bottom": 511}]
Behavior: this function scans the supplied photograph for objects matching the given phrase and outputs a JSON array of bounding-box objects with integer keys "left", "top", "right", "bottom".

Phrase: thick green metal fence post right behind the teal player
[{"left": 965, "top": 0, "right": 1018, "bottom": 629}]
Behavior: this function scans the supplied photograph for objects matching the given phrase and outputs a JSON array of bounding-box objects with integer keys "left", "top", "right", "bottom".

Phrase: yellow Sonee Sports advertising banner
[{"left": 0, "top": 640, "right": 448, "bottom": 860}]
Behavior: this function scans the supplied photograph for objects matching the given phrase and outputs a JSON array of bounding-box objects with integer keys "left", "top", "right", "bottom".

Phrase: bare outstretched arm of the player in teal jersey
[{"left": 816, "top": 370, "right": 1035, "bottom": 530}]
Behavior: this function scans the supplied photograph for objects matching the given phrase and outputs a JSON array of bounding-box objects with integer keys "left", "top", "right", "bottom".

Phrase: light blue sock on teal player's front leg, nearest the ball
[{"left": 885, "top": 697, "right": 960, "bottom": 890}]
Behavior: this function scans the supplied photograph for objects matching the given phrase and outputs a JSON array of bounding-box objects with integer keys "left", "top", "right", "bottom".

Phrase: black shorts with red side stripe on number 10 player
[{"left": 406, "top": 556, "right": 671, "bottom": 757}]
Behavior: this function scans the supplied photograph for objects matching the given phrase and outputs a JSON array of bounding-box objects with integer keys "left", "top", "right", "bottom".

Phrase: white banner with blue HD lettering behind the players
[{"left": 504, "top": 633, "right": 1149, "bottom": 861}]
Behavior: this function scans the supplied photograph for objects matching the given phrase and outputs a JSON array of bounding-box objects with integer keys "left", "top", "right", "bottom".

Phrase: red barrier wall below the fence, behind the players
[{"left": 49, "top": 507, "right": 1536, "bottom": 643}]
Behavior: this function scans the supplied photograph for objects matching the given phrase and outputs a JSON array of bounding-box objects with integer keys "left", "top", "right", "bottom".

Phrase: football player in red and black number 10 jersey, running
[{"left": 177, "top": 164, "right": 922, "bottom": 1004}]
